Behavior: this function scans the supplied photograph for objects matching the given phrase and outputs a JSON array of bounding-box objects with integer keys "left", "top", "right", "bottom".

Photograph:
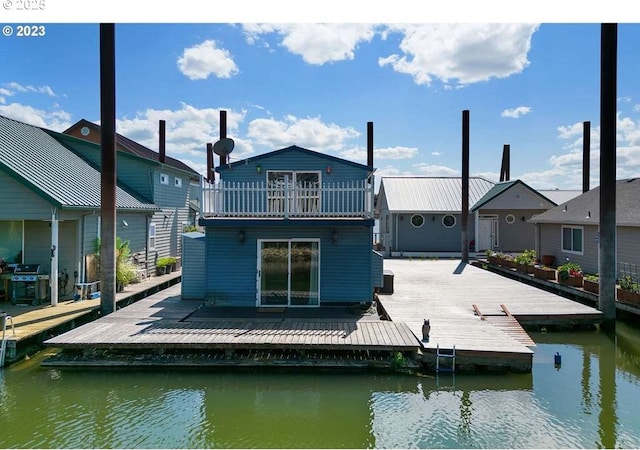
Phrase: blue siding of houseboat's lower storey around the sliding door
[{"left": 206, "top": 226, "right": 373, "bottom": 306}]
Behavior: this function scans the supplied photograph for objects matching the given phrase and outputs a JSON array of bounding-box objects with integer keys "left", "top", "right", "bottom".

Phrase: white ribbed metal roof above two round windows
[{"left": 380, "top": 177, "right": 494, "bottom": 213}]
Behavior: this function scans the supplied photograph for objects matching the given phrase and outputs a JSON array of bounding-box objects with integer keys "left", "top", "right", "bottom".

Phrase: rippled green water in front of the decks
[{"left": 0, "top": 323, "right": 640, "bottom": 448}]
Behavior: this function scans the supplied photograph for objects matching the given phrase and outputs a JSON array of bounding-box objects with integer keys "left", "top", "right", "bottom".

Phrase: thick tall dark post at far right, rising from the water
[{"left": 598, "top": 23, "right": 618, "bottom": 328}]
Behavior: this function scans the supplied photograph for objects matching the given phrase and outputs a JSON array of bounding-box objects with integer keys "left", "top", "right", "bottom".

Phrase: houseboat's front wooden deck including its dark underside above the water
[{"left": 44, "top": 285, "right": 420, "bottom": 367}]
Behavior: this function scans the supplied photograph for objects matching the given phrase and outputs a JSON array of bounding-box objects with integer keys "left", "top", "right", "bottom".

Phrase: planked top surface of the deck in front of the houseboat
[{"left": 45, "top": 284, "right": 419, "bottom": 351}]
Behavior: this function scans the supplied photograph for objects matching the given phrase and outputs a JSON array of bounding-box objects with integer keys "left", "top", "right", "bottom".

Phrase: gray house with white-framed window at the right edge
[{"left": 530, "top": 178, "right": 640, "bottom": 274}]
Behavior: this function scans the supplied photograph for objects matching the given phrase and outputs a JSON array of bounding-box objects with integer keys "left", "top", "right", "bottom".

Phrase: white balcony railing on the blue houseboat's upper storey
[{"left": 201, "top": 180, "right": 374, "bottom": 218}]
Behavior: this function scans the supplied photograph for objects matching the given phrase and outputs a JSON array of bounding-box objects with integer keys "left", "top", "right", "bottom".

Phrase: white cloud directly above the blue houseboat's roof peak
[{"left": 247, "top": 116, "right": 360, "bottom": 151}]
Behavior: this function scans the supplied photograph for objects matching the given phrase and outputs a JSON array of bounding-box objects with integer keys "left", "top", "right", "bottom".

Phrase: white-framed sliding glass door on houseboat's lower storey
[{"left": 257, "top": 239, "right": 320, "bottom": 306}]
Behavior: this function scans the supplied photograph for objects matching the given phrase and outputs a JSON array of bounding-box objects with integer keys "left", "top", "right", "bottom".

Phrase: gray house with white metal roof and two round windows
[{"left": 376, "top": 177, "right": 494, "bottom": 256}]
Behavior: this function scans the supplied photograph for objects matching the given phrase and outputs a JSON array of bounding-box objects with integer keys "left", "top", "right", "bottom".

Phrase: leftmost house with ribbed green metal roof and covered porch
[{"left": 0, "top": 116, "right": 159, "bottom": 304}]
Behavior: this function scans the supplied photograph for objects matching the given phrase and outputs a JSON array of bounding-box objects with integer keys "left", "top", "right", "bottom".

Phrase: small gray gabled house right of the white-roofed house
[{"left": 471, "top": 180, "right": 556, "bottom": 252}]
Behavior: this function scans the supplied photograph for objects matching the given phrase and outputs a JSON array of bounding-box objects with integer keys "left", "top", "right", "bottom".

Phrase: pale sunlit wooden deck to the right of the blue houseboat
[{"left": 379, "top": 259, "right": 601, "bottom": 371}]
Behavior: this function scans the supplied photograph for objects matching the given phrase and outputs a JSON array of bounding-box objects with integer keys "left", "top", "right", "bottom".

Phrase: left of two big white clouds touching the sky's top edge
[{"left": 243, "top": 23, "right": 375, "bottom": 65}]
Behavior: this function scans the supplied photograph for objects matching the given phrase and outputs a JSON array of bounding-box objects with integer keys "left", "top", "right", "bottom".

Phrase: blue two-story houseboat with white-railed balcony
[{"left": 183, "top": 142, "right": 383, "bottom": 307}]
